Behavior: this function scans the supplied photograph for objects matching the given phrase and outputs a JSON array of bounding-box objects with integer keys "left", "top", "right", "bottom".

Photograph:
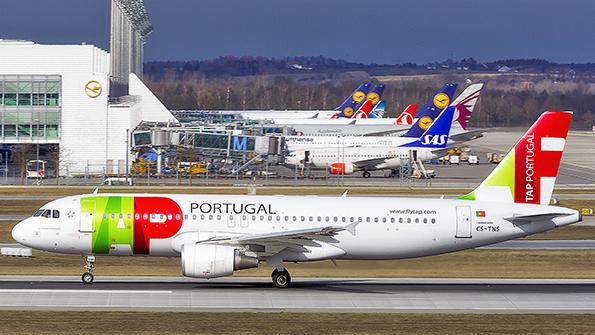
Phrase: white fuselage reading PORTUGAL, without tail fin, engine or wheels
[{"left": 13, "top": 194, "right": 579, "bottom": 261}]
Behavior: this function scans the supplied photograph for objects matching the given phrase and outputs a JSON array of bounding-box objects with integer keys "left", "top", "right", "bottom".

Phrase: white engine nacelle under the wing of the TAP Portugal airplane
[{"left": 182, "top": 244, "right": 258, "bottom": 278}]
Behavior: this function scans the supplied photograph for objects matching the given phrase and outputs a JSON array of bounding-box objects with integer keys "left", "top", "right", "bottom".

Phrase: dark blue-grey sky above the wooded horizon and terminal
[{"left": 0, "top": 0, "right": 595, "bottom": 64}]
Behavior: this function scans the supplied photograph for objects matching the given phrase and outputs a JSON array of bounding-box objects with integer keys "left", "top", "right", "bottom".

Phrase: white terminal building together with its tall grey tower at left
[{"left": 0, "top": 0, "right": 177, "bottom": 176}]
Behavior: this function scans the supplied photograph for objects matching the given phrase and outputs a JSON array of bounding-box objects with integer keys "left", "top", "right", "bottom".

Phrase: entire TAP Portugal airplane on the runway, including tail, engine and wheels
[{"left": 12, "top": 112, "right": 582, "bottom": 287}]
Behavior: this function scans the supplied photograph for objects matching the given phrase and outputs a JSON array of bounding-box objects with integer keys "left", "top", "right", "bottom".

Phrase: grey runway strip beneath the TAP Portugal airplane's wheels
[{"left": 0, "top": 276, "right": 595, "bottom": 313}]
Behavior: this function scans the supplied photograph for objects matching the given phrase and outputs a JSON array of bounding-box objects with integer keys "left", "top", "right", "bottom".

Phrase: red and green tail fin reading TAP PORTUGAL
[{"left": 459, "top": 112, "right": 572, "bottom": 205}]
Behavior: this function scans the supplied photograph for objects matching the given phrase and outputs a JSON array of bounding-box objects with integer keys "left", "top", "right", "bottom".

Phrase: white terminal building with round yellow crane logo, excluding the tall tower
[{"left": 0, "top": 40, "right": 175, "bottom": 175}]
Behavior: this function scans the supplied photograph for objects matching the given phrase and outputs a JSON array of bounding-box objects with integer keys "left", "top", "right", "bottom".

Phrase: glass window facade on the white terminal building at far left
[{"left": 0, "top": 75, "right": 62, "bottom": 138}]
